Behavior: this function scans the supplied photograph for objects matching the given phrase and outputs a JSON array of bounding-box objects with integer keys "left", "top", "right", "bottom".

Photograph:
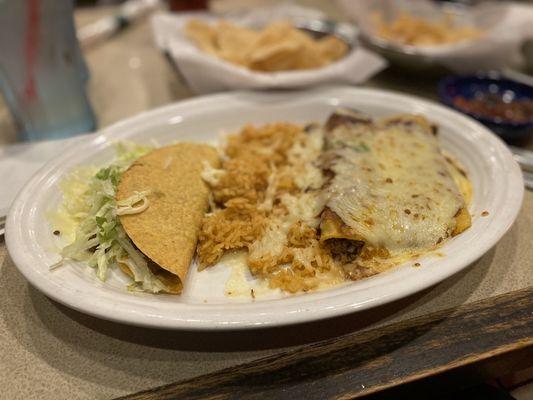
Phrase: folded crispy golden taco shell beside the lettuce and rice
[{"left": 116, "top": 143, "right": 220, "bottom": 293}]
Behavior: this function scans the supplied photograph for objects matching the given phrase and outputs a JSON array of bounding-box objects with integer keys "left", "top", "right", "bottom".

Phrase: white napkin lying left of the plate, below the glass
[{"left": 0, "top": 135, "right": 88, "bottom": 217}]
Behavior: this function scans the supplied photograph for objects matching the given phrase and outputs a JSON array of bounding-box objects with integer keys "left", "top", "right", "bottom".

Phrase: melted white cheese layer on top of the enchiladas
[{"left": 327, "top": 124, "right": 465, "bottom": 254}]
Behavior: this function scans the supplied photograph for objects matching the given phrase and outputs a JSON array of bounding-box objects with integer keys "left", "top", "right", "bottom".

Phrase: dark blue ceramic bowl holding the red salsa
[{"left": 439, "top": 74, "right": 533, "bottom": 140}]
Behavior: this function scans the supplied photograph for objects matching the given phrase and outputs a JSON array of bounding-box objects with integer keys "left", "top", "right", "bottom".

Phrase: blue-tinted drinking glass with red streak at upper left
[{"left": 0, "top": 0, "right": 96, "bottom": 141}]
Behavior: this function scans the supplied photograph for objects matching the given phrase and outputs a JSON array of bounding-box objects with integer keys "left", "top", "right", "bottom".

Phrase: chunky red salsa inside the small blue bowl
[{"left": 453, "top": 95, "right": 533, "bottom": 123}]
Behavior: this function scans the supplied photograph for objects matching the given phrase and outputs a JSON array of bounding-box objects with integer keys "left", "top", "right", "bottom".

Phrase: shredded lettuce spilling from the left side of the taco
[{"left": 54, "top": 142, "right": 166, "bottom": 293}]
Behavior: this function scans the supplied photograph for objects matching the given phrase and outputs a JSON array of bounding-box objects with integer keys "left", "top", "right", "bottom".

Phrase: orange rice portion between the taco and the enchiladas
[{"left": 198, "top": 123, "right": 343, "bottom": 293}]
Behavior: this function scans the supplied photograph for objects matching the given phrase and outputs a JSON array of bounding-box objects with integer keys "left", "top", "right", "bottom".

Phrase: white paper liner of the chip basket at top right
[{"left": 337, "top": 0, "right": 533, "bottom": 73}]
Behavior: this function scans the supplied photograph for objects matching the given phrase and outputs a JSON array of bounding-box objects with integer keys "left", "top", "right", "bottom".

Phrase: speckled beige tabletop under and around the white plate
[{"left": 0, "top": 3, "right": 533, "bottom": 399}]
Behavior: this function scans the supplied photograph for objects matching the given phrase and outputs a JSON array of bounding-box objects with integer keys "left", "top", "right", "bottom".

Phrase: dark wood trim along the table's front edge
[{"left": 116, "top": 288, "right": 533, "bottom": 400}]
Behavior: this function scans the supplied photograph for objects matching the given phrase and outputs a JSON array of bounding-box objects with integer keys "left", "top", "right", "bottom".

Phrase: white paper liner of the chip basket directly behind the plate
[{"left": 152, "top": 4, "right": 386, "bottom": 93}]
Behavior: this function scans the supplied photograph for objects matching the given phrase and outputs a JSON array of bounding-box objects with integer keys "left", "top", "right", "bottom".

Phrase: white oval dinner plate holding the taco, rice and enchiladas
[{"left": 6, "top": 87, "right": 524, "bottom": 330}]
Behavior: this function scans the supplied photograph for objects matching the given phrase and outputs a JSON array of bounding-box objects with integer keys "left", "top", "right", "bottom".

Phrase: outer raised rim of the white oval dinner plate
[{"left": 5, "top": 86, "right": 524, "bottom": 331}]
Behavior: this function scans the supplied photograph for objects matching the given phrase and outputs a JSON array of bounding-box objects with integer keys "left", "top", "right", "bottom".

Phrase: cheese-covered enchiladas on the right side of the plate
[{"left": 321, "top": 109, "right": 470, "bottom": 276}]
